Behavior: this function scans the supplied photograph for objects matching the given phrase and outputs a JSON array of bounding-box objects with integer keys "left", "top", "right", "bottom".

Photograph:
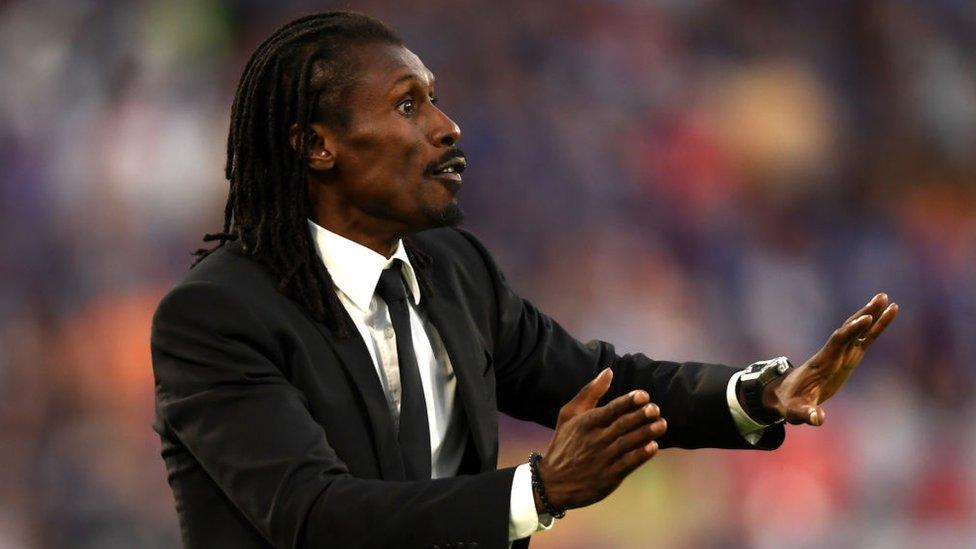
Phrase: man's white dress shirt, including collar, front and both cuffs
[{"left": 308, "top": 220, "right": 765, "bottom": 541}]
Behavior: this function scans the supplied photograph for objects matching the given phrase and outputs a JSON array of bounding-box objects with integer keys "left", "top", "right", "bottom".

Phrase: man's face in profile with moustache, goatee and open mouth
[{"left": 314, "top": 44, "right": 464, "bottom": 233}]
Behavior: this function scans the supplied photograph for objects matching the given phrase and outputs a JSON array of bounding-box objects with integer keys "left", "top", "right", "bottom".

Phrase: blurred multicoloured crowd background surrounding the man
[{"left": 0, "top": 0, "right": 976, "bottom": 549}]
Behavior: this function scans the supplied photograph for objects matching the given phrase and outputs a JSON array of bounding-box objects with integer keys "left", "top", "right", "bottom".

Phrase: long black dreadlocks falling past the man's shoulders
[{"left": 191, "top": 11, "right": 432, "bottom": 338}]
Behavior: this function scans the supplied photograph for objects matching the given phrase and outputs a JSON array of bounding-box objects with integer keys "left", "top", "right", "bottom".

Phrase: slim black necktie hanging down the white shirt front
[{"left": 376, "top": 261, "right": 430, "bottom": 480}]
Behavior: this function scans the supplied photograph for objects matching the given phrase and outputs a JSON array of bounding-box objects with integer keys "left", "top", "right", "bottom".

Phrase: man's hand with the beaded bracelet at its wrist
[{"left": 536, "top": 368, "right": 667, "bottom": 512}]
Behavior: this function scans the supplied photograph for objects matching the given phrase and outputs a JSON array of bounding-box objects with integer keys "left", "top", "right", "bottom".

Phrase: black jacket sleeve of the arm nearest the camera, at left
[{"left": 151, "top": 282, "right": 514, "bottom": 548}]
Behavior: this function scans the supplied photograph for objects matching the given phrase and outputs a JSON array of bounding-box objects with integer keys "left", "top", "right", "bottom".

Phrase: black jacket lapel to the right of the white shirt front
[{"left": 422, "top": 289, "right": 498, "bottom": 470}]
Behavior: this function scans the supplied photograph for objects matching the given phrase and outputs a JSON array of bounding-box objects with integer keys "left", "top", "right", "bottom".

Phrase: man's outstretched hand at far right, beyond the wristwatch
[{"left": 763, "top": 294, "right": 898, "bottom": 425}]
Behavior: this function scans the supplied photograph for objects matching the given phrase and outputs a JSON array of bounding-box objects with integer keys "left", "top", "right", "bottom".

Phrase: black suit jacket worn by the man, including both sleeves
[{"left": 152, "top": 229, "right": 784, "bottom": 549}]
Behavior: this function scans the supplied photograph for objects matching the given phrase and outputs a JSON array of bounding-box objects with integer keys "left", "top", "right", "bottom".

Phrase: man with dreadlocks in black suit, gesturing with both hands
[{"left": 152, "top": 12, "right": 897, "bottom": 548}]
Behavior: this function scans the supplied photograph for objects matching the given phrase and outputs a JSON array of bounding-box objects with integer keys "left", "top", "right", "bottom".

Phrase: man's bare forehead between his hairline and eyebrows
[{"left": 346, "top": 44, "right": 434, "bottom": 95}]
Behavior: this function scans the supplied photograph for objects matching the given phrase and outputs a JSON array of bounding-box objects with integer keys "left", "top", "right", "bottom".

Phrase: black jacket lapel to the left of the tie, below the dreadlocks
[{"left": 315, "top": 322, "right": 406, "bottom": 480}]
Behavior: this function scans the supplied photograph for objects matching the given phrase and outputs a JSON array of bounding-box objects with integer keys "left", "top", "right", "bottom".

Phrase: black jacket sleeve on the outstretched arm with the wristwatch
[{"left": 461, "top": 231, "right": 785, "bottom": 450}]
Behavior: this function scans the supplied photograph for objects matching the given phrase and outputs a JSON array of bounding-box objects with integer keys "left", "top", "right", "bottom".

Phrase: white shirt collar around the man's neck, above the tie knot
[{"left": 308, "top": 219, "right": 420, "bottom": 312}]
